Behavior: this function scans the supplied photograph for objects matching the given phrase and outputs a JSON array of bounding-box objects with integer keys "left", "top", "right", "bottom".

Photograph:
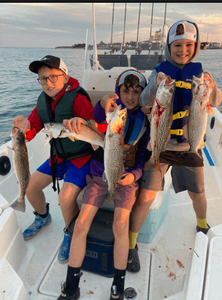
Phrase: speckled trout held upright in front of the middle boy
[{"left": 103, "top": 105, "right": 127, "bottom": 199}]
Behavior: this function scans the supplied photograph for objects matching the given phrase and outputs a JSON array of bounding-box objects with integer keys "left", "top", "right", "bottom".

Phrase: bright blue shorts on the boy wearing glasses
[{"left": 37, "top": 159, "right": 90, "bottom": 190}]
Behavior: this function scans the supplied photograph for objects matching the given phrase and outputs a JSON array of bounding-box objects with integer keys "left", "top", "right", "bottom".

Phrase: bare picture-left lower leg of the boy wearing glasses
[{"left": 26, "top": 171, "right": 52, "bottom": 215}]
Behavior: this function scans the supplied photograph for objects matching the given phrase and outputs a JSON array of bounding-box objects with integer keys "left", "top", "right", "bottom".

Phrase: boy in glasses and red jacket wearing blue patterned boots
[{"left": 13, "top": 55, "right": 94, "bottom": 263}]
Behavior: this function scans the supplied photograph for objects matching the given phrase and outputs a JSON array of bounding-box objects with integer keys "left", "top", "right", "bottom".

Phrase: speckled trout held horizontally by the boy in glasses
[{"left": 42, "top": 122, "right": 105, "bottom": 150}]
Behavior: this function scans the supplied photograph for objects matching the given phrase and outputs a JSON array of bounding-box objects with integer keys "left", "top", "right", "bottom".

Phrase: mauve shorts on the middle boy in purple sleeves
[{"left": 82, "top": 175, "right": 139, "bottom": 211}]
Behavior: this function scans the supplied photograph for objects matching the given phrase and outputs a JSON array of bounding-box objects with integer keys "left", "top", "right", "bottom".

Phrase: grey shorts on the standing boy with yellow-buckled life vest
[{"left": 139, "top": 163, "right": 205, "bottom": 194}]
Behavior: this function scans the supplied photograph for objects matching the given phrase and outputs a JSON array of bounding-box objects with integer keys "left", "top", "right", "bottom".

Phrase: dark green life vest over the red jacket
[{"left": 37, "top": 86, "right": 93, "bottom": 161}]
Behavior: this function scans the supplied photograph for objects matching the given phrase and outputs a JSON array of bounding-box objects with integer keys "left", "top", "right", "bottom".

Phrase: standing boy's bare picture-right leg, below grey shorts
[{"left": 187, "top": 191, "right": 207, "bottom": 219}]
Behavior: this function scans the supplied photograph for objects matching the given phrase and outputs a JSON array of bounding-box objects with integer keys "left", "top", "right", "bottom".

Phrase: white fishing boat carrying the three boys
[{"left": 0, "top": 2, "right": 222, "bottom": 300}]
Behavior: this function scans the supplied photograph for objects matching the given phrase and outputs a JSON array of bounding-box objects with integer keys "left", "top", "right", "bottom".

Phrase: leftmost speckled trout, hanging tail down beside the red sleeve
[{"left": 10, "top": 127, "right": 30, "bottom": 212}]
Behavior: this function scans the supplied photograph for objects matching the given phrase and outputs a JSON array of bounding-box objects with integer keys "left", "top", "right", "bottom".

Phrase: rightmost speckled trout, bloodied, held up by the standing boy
[{"left": 187, "top": 73, "right": 214, "bottom": 155}]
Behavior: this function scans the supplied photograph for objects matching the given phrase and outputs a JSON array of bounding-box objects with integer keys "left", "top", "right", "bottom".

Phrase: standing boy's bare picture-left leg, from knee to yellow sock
[{"left": 130, "top": 188, "right": 158, "bottom": 232}]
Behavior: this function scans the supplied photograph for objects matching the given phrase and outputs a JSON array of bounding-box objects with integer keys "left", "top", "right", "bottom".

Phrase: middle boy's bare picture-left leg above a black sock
[{"left": 69, "top": 204, "right": 99, "bottom": 268}]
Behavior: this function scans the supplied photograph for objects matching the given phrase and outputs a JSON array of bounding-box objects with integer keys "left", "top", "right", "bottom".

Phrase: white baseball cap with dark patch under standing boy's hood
[{"left": 169, "top": 20, "right": 197, "bottom": 44}]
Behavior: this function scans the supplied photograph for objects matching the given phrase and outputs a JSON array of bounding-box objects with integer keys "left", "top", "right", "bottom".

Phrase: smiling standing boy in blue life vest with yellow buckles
[{"left": 127, "top": 20, "right": 222, "bottom": 272}]
